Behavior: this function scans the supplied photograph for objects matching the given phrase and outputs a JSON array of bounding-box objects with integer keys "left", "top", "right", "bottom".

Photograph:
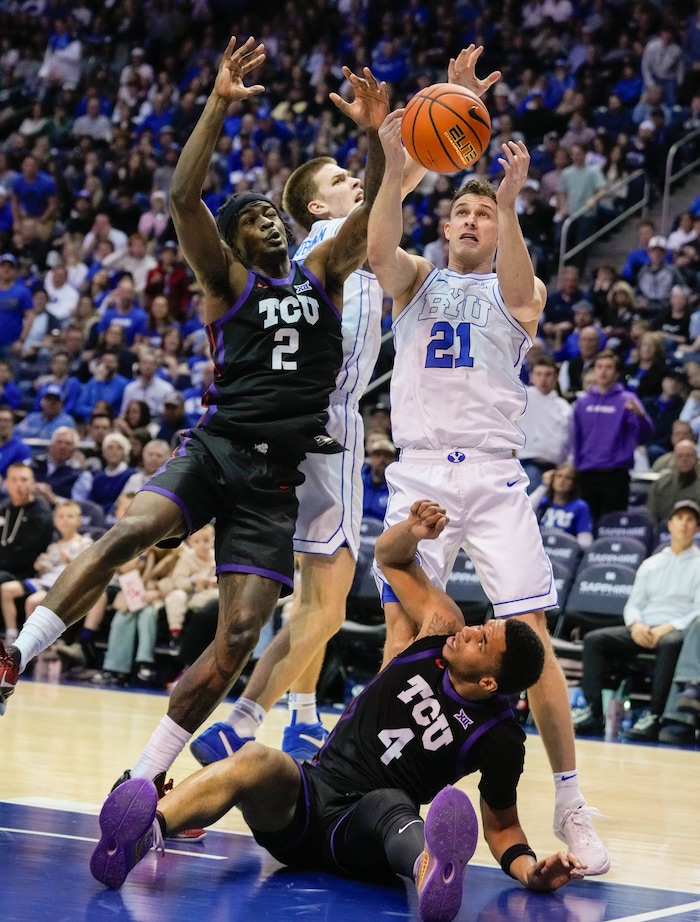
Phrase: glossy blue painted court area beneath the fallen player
[{"left": 0, "top": 802, "right": 700, "bottom": 922}]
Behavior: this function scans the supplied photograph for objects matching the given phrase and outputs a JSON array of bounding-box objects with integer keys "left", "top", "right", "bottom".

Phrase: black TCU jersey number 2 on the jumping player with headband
[{"left": 200, "top": 262, "right": 342, "bottom": 463}]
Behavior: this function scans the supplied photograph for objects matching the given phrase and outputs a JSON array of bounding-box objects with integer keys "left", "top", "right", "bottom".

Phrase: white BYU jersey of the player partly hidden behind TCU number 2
[{"left": 294, "top": 218, "right": 383, "bottom": 400}]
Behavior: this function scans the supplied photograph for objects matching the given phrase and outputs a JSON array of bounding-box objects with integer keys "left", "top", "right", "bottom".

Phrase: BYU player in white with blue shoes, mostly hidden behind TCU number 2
[{"left": 192, "top": 45, "right": 500, "bottom": 763}]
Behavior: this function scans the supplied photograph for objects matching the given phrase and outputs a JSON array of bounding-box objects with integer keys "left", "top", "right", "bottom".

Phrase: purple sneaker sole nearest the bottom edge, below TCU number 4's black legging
[{"left": 416, "top": 785, "right": 479, "bottom": 922}]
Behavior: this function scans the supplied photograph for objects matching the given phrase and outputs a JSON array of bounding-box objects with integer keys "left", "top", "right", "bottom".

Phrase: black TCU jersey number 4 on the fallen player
[{"left": 309, "top": 636, "right": 525, "bottom": 810}]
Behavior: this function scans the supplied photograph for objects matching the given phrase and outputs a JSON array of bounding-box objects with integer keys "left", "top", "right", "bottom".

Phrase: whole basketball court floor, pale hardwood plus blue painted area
[{"left": 0, "top": 680, "right": 700, "bottom": 922}]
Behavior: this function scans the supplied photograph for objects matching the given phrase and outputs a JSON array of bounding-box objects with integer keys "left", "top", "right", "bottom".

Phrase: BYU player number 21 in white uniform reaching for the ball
[{"left": 368, "top": 110, "right": 610, "bottom": 874}]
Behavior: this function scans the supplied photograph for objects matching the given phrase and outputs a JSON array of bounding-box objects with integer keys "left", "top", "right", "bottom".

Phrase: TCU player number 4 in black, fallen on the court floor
[{"left": 90, "top": 500, "right": 584, "bottom": 920}]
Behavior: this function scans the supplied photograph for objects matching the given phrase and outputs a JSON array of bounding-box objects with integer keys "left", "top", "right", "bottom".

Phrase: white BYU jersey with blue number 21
[{"left": 391, "top": 269, "right": 532, "bottom": 452}]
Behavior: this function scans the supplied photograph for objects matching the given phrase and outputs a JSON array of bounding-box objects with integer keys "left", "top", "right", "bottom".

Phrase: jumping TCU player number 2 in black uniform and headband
[{"left": 0, "top": 38, "right": 389, "bottom": 777}]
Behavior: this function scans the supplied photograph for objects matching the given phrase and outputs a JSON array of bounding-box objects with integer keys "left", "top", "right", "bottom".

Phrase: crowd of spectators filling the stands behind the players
[{"left": 0, "top": 0, "right": 700, "bottom": 732}]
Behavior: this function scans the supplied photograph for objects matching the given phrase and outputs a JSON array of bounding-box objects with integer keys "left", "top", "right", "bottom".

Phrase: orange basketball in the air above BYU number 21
[{"left": 401, "top": 83, "right": 491, "bottom": 173}]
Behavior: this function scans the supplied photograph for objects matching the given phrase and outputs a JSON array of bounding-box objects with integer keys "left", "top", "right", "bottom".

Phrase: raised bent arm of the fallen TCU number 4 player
[{"left": 375, "top": 499, "right": 464, "bottom": 637}]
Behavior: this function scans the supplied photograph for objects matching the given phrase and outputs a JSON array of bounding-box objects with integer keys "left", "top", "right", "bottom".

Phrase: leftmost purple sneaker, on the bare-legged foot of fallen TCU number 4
[{"left": 90, "top": 778, "right": 165, "bottom": 890}]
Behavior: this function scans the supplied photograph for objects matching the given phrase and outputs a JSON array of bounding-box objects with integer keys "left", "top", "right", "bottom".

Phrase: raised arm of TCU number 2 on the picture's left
[{"left": 170, "top": 37, "right": 265, "bottom": 300}]
